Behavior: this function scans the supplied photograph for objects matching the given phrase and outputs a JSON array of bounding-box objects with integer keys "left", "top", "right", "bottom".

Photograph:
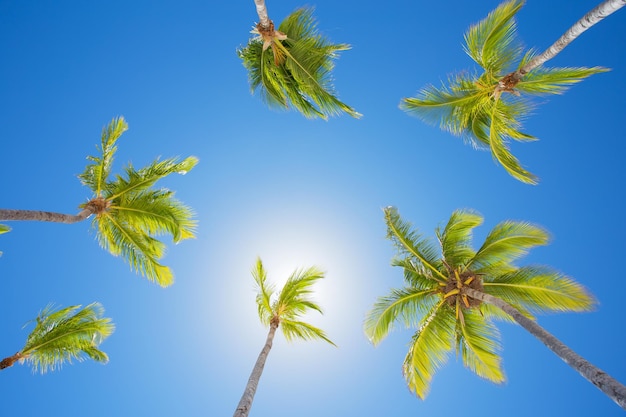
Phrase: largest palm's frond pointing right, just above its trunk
[{"left": 484, "top": 266, "right": 595, "bottom": 313}]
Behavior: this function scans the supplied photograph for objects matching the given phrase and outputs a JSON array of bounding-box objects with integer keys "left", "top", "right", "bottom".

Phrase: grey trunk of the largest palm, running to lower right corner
[{"left": 463, "top": 287, "right": 626, "bottom": 410}]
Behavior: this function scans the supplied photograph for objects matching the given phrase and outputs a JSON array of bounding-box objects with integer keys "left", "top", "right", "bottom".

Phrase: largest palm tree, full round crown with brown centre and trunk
[{"left": 365, "top": 207, "right": 626, "bottom": 408}]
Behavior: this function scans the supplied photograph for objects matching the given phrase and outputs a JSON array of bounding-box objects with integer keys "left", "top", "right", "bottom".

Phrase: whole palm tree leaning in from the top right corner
[{"left": 400, "top": 0, "right": 612, "bottom": 184}]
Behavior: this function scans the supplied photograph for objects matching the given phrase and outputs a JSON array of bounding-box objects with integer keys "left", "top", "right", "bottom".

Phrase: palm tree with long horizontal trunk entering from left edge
[{"left": 0, "top": 117, "right": 198, "bottom": 287}]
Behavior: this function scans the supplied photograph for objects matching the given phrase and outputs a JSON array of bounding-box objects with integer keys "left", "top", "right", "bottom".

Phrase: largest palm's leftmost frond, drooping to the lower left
[{"left": 364, "top": 281, "right": 441, "bottom": 345}]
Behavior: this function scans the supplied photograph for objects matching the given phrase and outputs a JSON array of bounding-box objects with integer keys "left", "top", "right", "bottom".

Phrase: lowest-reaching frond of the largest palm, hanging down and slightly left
[{"left": 402, "top": 301, "right": 455, "bottom": 399}]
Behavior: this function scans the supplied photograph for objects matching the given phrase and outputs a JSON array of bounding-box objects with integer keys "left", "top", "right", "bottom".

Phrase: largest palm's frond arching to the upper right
[{"left": 466, "top": 220, "right": 549, "bottom": 272}]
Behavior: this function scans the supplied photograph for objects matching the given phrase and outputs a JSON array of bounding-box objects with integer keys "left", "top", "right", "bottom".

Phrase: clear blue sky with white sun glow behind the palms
[{"left": 0, "top": 0, "right": 626, "bottom": 417}]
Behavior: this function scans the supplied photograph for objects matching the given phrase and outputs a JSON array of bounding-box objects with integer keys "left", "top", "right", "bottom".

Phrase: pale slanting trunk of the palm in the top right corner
[{"left": 498, "top": 0, "right": 626, "bottom": 91}]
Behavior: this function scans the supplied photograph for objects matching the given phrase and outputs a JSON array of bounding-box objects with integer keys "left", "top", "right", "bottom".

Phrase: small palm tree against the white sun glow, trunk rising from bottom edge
[{"left": 234, "top": 259, "right": 335, "bottom": 417}]
